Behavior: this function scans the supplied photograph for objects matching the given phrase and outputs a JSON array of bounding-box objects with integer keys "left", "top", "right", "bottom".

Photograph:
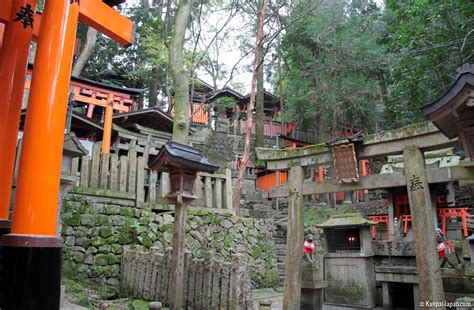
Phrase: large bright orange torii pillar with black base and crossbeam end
[{"left": 0, "top": 0, "right": 133, "bottom": 309}]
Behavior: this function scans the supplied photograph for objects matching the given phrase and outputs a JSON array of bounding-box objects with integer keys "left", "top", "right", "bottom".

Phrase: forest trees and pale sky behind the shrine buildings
[{"left": 68, "top": 0, "right": 474, "bottom": 142}]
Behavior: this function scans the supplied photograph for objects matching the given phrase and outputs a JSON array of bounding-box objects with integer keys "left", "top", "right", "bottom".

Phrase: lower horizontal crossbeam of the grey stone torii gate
[{"left": 269, "top": 166, "right": 473, "bottom": 198}]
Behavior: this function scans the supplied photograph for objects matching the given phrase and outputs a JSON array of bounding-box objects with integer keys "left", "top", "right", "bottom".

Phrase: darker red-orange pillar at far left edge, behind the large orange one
[{"left": 0, "top": 0, "right": 36, "bottom": 222}]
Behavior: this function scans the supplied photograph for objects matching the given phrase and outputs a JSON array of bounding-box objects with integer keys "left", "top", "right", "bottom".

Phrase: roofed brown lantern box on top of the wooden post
[{"left": 150, "top": 141, "right": 219, "bottom": 204}]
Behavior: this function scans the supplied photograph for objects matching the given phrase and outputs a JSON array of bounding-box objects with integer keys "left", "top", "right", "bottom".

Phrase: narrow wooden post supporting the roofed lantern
[{"left": 169, "top": 203, "right": 186, "bottom": 310}]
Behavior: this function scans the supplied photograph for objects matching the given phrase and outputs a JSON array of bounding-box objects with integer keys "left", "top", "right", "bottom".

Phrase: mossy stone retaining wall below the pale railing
[{"left": 61, "top": 194, "right": 278, "bottom": 287}]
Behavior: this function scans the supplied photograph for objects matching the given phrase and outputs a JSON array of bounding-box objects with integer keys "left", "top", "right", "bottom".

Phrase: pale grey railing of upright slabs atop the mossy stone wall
[{"left": 63, "top": 144, "right": 232, "bottom": 212}]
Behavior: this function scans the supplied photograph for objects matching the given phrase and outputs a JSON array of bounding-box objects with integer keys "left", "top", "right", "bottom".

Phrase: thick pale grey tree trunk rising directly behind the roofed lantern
[{"left": 169, "top": 0, "right": 191, "bottom": 144}]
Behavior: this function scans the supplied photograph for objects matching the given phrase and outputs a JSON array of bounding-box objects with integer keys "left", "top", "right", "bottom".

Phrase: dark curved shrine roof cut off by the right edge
[{"left": 421, "top": 64, "right": 474, "bottom": 139}]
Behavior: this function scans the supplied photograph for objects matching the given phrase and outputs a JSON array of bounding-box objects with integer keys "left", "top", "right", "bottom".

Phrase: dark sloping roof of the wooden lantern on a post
[{"left": 150, "top": 141, "right": 219, "bottom": 173}]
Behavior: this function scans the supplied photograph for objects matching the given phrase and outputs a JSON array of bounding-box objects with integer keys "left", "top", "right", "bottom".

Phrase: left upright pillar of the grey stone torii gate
[{"left": 283, "top": 166, "right": 304, "bottom": 310}]
